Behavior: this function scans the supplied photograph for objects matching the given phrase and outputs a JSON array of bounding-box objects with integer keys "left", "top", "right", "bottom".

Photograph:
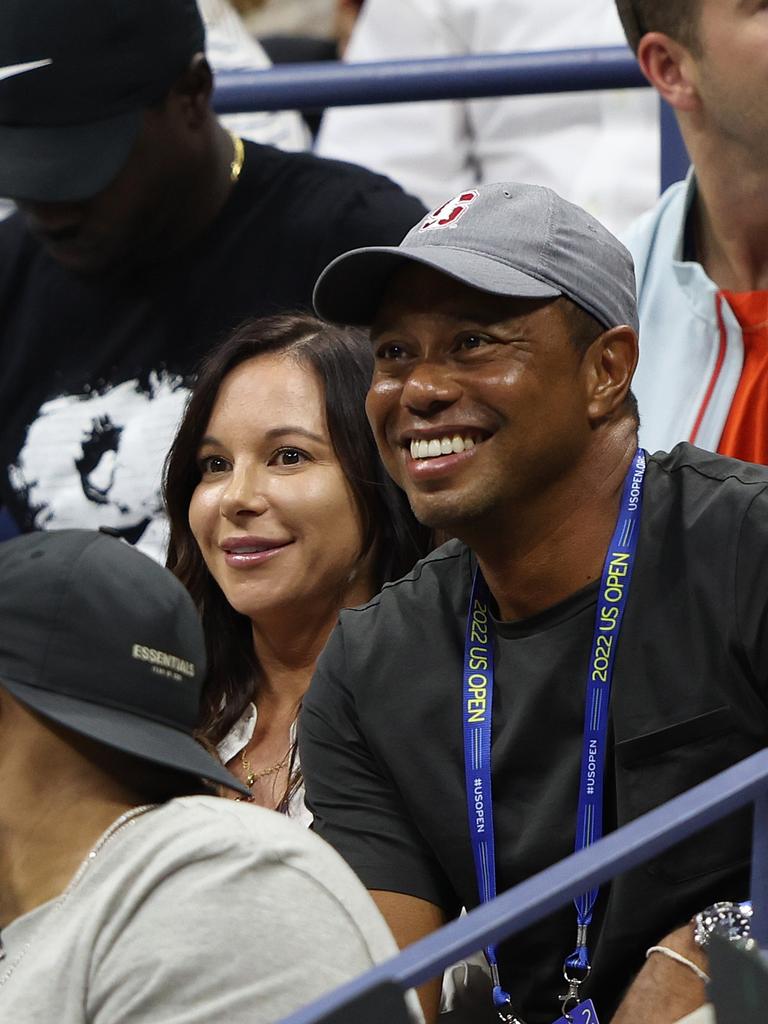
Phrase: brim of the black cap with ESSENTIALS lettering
[{"left": 2, "top": 676, "right": 250, "bottom": 797}]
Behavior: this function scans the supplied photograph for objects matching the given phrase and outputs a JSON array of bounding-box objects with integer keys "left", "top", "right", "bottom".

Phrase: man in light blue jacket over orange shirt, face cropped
[{"left": 616, "top": 0, "right": 768, "bottom": 463}]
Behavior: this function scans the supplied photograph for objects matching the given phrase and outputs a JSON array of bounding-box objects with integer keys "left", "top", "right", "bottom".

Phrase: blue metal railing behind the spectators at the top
[{"left": 214, "top": 46, "right": 688, "bottom": 188}]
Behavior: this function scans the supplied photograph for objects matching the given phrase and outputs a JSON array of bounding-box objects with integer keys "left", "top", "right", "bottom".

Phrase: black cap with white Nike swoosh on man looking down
[{"left": 0, "top": 0, "right": 205, "bottom": 202}]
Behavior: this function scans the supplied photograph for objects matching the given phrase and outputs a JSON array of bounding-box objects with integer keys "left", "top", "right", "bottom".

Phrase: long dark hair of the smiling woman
[{"left": 163, "top": 313, "right": 431, "bottom": 743}]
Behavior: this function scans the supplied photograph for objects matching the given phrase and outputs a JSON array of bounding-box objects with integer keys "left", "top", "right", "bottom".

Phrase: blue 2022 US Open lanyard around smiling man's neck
[{"left": 462, "top": 449, "right": 646, "bottom": 1024}]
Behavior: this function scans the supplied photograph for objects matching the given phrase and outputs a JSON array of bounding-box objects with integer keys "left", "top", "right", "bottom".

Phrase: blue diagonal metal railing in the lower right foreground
[{"left": 283, "top": 751, "right": 768, "bottom": 1024}]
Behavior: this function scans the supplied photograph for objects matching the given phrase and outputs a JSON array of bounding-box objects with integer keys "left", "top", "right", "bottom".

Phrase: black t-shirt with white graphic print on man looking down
[{"left": 0, "top": 142, "right": 424, "bottom": 555}]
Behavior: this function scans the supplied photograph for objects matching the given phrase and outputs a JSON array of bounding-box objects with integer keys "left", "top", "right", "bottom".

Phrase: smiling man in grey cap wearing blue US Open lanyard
[{"left": 299, "top": 184, "right": 768, "bottom": 1024}]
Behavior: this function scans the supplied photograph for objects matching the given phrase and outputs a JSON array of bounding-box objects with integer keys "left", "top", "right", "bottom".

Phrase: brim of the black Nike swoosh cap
[{"left": 0, "top": 111, "right": 142, "bottom": 203}]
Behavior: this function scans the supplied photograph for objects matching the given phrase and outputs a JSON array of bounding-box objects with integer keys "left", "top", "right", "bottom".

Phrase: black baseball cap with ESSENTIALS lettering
[{"left": 0, "top": 529, "right": 248, "bottom": 795}]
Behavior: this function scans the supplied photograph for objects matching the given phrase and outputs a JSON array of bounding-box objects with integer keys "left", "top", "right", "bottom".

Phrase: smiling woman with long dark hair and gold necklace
[{"left": 164, "top": 314, "right": 428, "bottom": 818}]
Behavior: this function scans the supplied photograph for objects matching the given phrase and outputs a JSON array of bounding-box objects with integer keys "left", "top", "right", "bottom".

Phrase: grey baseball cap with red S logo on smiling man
[{"left": 314, "top": 181, "right": 638, "bottom": 331}]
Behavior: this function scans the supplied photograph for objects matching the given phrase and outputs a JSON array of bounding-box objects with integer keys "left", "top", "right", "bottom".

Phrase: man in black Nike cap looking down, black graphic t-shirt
[{"left": 0, "top": 0, "right": 423, "bottom": 555}]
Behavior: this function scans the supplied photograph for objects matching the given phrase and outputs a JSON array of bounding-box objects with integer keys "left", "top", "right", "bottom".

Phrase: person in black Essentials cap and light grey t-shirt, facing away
[{"left": 0, "top": 530, "right": 421, "bottom": 1024}]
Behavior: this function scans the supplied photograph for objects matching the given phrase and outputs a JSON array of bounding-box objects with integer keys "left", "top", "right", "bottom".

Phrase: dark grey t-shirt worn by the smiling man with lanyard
[{"left": 299, "top": 444, "right": 768, "bottom": 1024}]
